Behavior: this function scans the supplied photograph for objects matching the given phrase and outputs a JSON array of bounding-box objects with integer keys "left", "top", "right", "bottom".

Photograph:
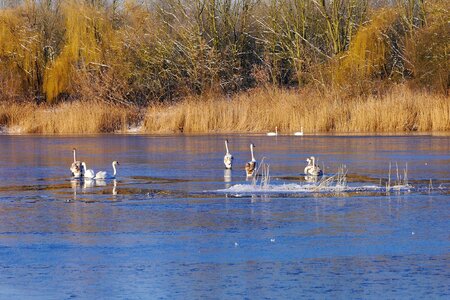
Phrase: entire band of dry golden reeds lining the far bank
[{"left": 0, "top": 87, "right": 450, "bottom": 134}]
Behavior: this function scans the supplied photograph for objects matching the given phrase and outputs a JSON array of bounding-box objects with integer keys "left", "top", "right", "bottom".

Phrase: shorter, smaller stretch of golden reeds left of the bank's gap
[{"left": 0, "top": 102, "right": 139, "bottom": 134}]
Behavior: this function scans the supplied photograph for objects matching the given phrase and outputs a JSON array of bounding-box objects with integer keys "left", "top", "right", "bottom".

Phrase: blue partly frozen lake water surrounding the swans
[{"left": 0, "top": 135, "right": 450, "bottom": 299}]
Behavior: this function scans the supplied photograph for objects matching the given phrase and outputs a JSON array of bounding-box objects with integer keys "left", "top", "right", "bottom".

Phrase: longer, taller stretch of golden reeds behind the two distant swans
[{"left": 144, "top": 86, "right": 450, "bottom": 133}]
